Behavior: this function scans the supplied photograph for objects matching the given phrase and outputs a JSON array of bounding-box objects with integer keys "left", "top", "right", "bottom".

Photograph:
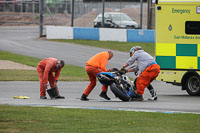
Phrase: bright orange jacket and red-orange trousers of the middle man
[{"left": 83, "top": 52, "right": 109, "bottom": 96}]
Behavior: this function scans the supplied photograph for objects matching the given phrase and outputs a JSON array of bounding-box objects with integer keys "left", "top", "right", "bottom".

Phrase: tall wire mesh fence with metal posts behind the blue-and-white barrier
[{"left": 0, "top": 0, "right": 154, "bottom": 29}]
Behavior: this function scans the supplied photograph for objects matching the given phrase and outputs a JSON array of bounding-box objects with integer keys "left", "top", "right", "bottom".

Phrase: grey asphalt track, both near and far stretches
[{"left": 0, "top": 27, "right": 200, "bottom": 114}]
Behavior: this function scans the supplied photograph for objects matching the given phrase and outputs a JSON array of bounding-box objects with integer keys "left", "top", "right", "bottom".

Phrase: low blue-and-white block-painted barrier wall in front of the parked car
[{"left": 46, "top": 26, "right": 155, "bottom": 42}]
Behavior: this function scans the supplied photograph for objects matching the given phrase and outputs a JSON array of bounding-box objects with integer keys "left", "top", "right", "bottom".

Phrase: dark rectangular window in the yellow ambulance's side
[{"left": 185, "top": 21, "right": 200, "bottom": 34}]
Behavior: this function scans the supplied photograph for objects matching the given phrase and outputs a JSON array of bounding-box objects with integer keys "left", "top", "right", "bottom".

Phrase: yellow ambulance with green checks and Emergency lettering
[{"left": 153, "top": 0, "right": 200, "bottom": 96}]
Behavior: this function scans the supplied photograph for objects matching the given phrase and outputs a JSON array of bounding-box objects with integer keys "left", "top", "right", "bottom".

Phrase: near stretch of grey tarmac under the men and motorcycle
[{"left": 0, "top": 81, "right": 200, "bottom": 114}]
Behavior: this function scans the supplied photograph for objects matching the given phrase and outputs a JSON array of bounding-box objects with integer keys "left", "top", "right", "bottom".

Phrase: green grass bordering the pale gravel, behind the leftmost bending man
[{"left": 0, "top": 51, "right": 88, "bottom": 81}]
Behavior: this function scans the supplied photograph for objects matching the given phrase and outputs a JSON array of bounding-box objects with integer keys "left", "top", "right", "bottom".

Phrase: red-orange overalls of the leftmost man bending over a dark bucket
[{"left": 37, "top": 58, "right": 61, "bottom": 96}]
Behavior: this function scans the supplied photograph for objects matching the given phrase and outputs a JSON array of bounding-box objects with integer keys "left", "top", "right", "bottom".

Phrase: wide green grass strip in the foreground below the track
[{"left": 0, "top": 105, "right": 200, "bottom": 133}]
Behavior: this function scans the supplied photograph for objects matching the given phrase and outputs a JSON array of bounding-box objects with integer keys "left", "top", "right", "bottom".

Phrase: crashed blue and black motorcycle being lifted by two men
[{"left": 97, "top": 68, "right": 137, "bottom": 101}]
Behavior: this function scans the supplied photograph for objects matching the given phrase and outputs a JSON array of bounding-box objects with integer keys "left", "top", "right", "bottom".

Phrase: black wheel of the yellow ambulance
[{"left": 185, "top": 75, "right": 200, "bottom": 96}]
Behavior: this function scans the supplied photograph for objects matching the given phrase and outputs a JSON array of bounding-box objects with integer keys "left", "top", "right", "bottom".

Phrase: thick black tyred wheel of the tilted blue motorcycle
[{"left": 110, "top": 83, "right": 130, "bottom": 101}]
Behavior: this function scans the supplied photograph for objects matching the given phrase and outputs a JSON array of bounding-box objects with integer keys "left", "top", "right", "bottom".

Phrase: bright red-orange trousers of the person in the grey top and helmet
[{"left": 136, "top": 64, "right": 160, "bottom": 95}]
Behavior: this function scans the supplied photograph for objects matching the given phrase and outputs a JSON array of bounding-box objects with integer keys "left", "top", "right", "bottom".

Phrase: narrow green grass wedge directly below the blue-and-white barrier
[{"left": 49, "top": 40, "right": 155, "bottom": 56}]
